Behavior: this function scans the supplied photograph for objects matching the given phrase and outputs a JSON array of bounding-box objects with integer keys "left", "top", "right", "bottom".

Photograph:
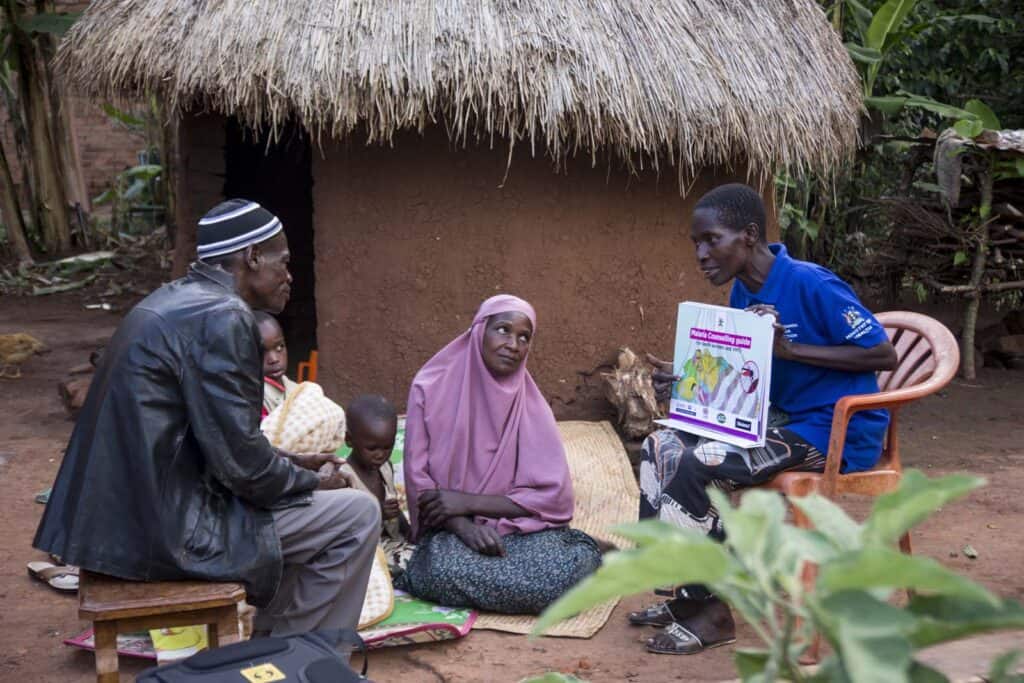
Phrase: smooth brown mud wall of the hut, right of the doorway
[{"left": 312, "top": 127, "right": 774, "bottom": 419}]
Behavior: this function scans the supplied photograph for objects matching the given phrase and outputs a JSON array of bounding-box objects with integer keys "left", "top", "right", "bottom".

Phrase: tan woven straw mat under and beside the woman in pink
[{"left": 473, "top": 422, "right": 640, "bottom": 638}]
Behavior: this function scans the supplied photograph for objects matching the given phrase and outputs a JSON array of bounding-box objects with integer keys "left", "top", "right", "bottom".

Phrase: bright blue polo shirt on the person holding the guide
[{"left": 729, "top": 244, "right": 889, "bottom": 472}]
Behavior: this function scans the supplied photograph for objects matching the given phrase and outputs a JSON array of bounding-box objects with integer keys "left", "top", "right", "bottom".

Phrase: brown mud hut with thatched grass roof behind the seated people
[{"left": 59, "top": 0, "right": 861, "bottom": 417}]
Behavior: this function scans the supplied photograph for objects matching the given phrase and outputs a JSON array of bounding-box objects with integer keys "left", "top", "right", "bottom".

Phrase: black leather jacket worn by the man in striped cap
[{"left": 33, "top": 263, "right": 317, "bottom": 606}]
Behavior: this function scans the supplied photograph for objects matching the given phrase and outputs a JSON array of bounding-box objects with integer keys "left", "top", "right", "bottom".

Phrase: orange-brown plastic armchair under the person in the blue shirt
[{"left": 758, "top": 310, "right": 959, "bottom": 661}]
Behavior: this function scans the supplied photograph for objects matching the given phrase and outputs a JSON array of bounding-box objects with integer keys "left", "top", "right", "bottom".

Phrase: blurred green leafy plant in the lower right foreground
[{"left": 535, "top": 470, "right": 1024, "bottom": 683}]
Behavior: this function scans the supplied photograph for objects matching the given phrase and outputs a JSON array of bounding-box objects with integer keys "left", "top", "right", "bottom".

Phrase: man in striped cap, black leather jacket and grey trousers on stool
[{"left": 34, "top": 200, "right": 380, "bottom": 635}]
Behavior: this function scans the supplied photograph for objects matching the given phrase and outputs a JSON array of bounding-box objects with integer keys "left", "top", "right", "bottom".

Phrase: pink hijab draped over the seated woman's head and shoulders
[{"left": 404, "top": 294, "right": 572, "bottom": 539}]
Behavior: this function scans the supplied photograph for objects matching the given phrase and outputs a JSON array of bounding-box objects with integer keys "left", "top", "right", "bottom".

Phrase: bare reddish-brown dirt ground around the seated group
[{"left": 0, "top": 295, "right": 1024, "bottom": 682}]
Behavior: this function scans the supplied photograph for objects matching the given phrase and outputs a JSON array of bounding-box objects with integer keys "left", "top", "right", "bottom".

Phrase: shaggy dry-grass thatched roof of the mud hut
[{"left": 59, "top": 0, "right": 861, "bottom": 180}]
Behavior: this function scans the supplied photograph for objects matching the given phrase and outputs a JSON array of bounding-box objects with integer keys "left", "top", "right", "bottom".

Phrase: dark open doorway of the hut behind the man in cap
[{"left": 224, "top": 118, "right": 316, "bottom": 378}]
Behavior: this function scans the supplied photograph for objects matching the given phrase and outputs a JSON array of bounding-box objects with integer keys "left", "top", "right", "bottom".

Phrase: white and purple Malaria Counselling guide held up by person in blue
[{"left": 658, "top": 301, "right": 775, "bottom": 447}]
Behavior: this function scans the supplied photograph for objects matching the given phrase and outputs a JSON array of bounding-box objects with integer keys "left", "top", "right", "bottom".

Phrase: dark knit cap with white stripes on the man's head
[{"left": 196, "top": 200, "right": 283, "bottom": 260}]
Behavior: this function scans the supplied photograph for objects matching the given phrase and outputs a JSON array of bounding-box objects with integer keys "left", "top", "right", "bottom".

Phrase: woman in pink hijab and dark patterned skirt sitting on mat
[{"left": 395, "top": 295, "right": 599, "bottom": 612}]
